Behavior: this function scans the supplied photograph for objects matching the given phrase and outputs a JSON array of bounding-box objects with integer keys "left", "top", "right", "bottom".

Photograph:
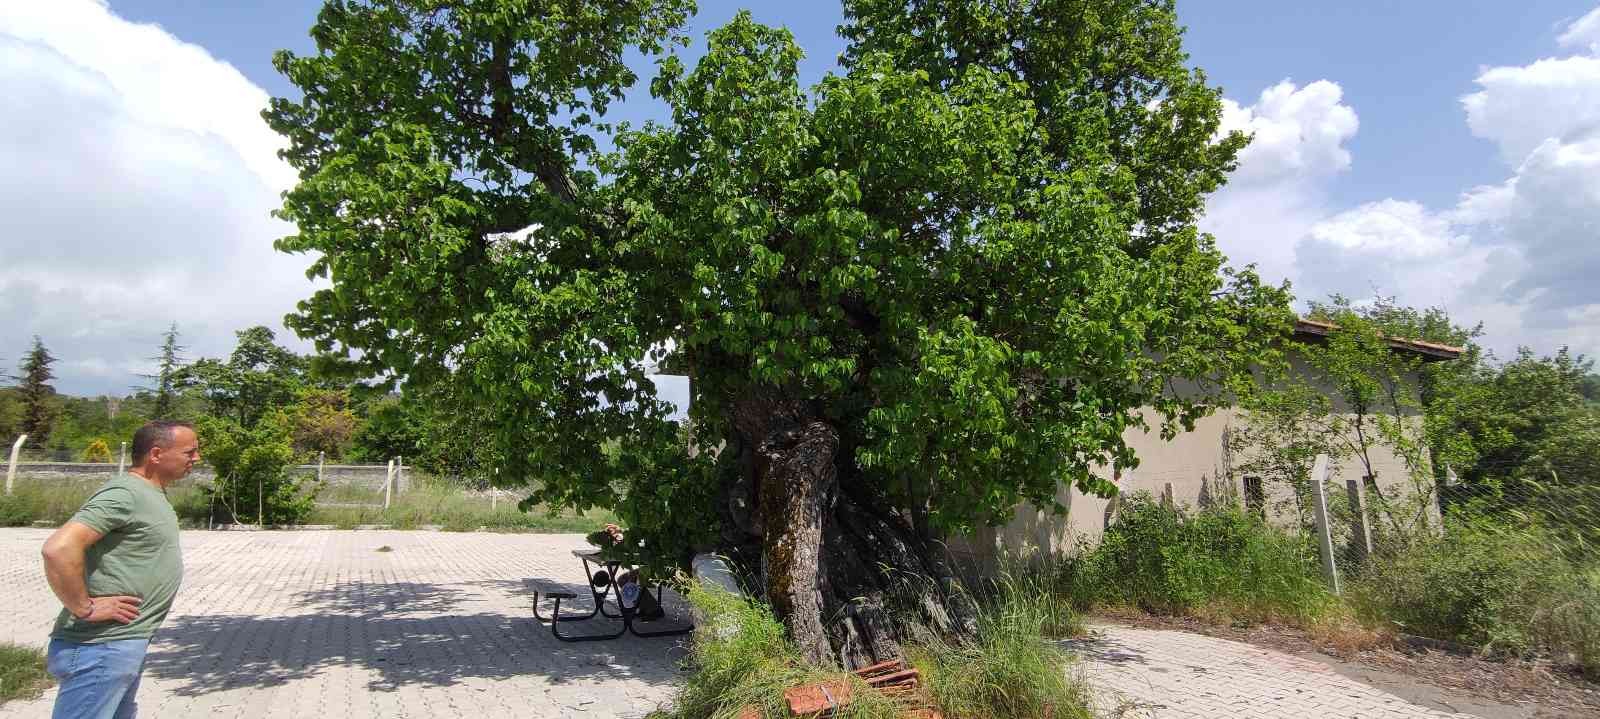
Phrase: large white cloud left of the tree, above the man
[{"left": 0, "top": 0, "right": 312, "bottom": 392}]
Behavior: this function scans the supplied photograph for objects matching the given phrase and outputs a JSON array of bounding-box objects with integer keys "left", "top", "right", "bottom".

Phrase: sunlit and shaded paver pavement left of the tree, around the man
[{"left": 0, "top": 530, "right": 683, "bottom": 719}]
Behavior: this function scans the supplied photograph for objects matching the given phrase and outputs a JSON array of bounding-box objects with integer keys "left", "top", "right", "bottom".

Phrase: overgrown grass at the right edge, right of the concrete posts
[{"left": 1349, "top": 512, "right": 1600, "bottom": 677}]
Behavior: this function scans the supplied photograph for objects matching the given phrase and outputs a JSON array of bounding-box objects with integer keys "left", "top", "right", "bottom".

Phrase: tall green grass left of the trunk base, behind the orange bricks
[{"left": 654, "top": 584, "right": 899, "bottom": 719}]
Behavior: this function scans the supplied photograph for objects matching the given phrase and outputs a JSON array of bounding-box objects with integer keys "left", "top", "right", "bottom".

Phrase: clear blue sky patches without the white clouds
[{"left": 110, "top": 0, "right": 1595, "bottom": 203}]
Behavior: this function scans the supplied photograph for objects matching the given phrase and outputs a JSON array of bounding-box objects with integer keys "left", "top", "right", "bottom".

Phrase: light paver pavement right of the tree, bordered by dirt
[{"left": 1067, "top": 625, "right": 1477, "bottom": 719}]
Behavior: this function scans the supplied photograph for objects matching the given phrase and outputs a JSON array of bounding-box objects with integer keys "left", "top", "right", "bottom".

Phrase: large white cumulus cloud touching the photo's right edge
[{"left": 1294, "top": 10, "right": 1600, "bottom": 355}]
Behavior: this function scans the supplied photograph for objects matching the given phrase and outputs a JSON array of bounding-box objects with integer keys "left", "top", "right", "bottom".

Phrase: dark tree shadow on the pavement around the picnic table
[{"left": 146, "top": 580, "right": 686, "bottom": 697}]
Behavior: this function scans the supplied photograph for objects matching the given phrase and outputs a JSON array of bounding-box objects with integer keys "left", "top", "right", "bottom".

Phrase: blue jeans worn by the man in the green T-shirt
[{"left": 46, "top": 639, "right": 150, "bottom": 719}]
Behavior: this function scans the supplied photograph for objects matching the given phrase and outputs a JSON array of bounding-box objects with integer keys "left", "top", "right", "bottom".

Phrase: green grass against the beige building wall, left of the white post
[{"left": 1061, "top": 492, "right": 1338, "bottom": 626}]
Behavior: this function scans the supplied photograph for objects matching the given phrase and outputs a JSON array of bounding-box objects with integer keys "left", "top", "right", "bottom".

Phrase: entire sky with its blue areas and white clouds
[{"left": 0, "top": 0, "right": 1600, "bottom": 392}]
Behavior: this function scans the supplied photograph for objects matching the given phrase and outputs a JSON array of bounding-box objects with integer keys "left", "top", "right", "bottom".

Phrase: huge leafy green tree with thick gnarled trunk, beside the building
[{"left": 267, "top": 0, "right": 1286, "bottom": 663}]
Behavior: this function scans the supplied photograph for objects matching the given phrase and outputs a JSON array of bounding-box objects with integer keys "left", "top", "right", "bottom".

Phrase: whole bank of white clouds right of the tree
[{"left": 1203, "top": 10, "right": 1600, "bottom": 365}]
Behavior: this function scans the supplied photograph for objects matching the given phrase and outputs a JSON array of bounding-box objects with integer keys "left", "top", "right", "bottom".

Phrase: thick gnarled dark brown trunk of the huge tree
[{"left": 725, "top": 397, "right": 976, "bottom": 668}]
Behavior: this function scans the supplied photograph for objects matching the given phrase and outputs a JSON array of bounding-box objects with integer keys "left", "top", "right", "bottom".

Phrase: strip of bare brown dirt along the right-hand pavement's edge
[{"left": 1096, "top": 610, "right": 1600, "bottom": 719}]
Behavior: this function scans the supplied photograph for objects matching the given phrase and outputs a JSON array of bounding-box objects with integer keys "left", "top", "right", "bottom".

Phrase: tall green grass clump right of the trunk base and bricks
[{"left": 910, "top": 568, "right": 1091, "bottom": 719}]
